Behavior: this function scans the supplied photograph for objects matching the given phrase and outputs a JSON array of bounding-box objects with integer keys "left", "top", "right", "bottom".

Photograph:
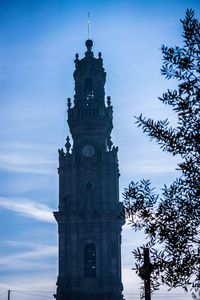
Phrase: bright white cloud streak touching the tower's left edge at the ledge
[{"left": 0, "top": 197, "right": 55, "bottom": 223}]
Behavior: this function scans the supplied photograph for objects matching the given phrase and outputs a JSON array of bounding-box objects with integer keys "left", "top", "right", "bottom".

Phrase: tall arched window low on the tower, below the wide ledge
[{"left": 84, "top": 243, "right": 96, "bottom": 277}]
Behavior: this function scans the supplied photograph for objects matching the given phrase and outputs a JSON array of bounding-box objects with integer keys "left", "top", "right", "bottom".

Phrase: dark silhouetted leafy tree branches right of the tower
[{"left": 124, "top": 9, "right": 200, "bottom": 297}]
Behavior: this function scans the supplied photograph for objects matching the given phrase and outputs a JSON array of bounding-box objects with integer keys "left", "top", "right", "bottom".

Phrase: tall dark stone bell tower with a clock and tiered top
[{"left": 54, "top": 40, "right": 124, "bottom": 300}]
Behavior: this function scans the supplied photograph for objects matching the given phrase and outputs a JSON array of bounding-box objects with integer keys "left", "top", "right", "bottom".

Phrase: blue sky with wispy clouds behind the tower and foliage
[{"left": 0, "top": 0, "right": 200, "bottom": 300}]
